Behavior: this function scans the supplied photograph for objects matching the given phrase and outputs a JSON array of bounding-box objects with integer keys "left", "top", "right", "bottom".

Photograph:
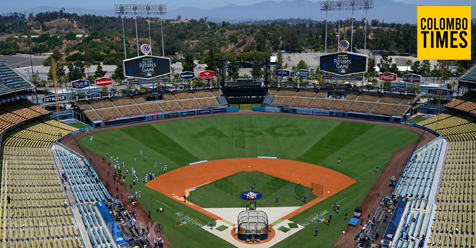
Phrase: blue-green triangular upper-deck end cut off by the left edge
[{"left": 0, "top": 61, "right": 35, "bottom": 95}]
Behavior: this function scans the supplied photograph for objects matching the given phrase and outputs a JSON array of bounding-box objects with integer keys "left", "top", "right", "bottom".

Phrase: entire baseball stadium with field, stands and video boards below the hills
[{"left": 0, "top": 3, "right": 476, "bottom": 248}]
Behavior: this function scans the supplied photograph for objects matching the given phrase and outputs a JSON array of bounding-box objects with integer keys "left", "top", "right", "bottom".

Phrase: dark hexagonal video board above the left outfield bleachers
[{"left": 122, "top": 56, "right": 170, "bottom": 79}]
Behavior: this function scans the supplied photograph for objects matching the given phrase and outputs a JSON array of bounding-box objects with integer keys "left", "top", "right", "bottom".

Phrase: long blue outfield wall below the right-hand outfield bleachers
[{"left": 253, "top": 106, "right": 404, "bottom": 124}]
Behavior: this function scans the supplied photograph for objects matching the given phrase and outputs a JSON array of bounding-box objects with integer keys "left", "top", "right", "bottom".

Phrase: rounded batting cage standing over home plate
[{"left": 236, "top": 210, "right": 270, "bottom": 241}]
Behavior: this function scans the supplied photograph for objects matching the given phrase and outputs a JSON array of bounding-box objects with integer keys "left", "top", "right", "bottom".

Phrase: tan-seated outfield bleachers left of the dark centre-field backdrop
[{"left": 80, "top": 90, "right": 220, "bottom": 123}]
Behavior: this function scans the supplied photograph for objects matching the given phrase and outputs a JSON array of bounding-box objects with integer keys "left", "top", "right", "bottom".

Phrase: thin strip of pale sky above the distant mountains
[{"left": 0, "top": 0, "right": 476, "bottom": 13}]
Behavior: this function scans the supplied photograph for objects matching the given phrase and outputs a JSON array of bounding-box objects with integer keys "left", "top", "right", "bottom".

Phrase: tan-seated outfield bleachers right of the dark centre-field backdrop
[{"left": 269, "top": 89, "right": 416, "bottom": 116}]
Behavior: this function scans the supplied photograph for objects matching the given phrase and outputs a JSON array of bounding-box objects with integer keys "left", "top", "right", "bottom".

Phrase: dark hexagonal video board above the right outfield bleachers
[{"left": 319, "top": 52, "right": 368, "bottom": 75}]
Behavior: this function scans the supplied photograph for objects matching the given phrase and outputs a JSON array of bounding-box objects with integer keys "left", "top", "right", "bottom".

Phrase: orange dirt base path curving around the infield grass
[{"left": 146, "top": 158, "right": 355, "bottom": 220}]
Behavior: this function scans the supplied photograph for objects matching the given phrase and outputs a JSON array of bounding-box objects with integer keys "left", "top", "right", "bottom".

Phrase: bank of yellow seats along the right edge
[{"left": 419, "top": 103, "right": 476, "bottom": 247}]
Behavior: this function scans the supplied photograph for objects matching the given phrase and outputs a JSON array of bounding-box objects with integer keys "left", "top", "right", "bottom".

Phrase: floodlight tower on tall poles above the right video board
[{"left": 321, "top": 0, "right": 374, "bottom": 52}]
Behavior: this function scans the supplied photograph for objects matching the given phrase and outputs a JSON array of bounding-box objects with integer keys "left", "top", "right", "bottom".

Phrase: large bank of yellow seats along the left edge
[{"left": 0, "top": 122, "right": 83, "bottom": 247}]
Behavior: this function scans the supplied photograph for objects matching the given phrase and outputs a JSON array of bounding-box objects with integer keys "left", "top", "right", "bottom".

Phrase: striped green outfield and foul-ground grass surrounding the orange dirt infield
[{"left": 78, "top": 115, "right": 419, "bottom": 248}]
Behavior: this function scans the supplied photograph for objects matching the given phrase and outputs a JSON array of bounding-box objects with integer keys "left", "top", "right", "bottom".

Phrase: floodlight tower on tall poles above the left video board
[{"left": 114, "top": 4, "right": 167, "bottom": 57}]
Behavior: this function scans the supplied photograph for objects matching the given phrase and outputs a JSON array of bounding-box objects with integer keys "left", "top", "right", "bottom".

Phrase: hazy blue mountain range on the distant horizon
[{"left": 25, "top": 0, "right": 417, "bottom": 23}]
